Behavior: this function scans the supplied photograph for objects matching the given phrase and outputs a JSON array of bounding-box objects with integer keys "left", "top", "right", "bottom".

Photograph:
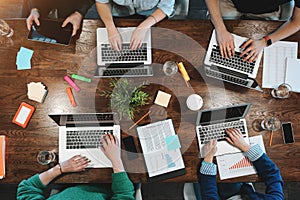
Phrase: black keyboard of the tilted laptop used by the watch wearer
[{"left": 209, "top": 45, "right": 255, "bottom": 74}]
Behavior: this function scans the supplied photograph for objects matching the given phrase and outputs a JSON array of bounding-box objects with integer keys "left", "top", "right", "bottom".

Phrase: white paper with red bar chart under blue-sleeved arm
[{"left": 217, "top": 135, "right": 265, "bottom": 180}]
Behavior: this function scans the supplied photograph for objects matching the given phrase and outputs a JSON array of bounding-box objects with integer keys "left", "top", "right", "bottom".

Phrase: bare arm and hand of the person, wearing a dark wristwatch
[{"left": 240, "top": 7, "right": 300, "bottom": 62}]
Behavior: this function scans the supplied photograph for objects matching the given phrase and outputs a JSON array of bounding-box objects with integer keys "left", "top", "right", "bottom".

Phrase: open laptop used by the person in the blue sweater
[{"left": 196, "top": 104, "right": 250, "bottom": 158}]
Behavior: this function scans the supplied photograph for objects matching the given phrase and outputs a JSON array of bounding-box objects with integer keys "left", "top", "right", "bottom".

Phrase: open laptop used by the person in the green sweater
[{"left": 49, "top": 113, "right": 120, "bottom": 168}]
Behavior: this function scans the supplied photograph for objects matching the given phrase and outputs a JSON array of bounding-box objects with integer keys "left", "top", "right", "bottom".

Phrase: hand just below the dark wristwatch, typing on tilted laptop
[{"left": 240, "top": 39, "right": 266, "bottom": 62}]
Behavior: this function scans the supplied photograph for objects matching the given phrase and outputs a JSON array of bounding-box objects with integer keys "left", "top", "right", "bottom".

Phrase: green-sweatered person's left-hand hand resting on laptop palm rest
[{"left": 60, "top": 155, "right": 90, "bottom": 173}]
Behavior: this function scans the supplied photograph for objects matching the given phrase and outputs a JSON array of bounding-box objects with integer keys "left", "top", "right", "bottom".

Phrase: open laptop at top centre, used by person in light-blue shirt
[{"left": 95, "top": 27, "right": 153, "bottom": 78}]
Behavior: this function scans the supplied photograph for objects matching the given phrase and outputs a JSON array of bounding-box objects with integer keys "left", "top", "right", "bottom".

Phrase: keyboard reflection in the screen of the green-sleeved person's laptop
[{"left": 67, "top": 113, "right": 114, "bottom": 122}]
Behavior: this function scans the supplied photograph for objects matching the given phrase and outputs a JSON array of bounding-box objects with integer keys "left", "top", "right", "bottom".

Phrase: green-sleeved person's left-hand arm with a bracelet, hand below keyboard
[{"left": 17, "top": 155, "right": 89, "bottom": 200}]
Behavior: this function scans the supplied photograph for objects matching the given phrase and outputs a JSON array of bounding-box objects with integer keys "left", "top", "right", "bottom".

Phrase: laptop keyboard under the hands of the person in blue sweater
[{"left": 198, "top": 121, "right": 246, "bottom": 144}]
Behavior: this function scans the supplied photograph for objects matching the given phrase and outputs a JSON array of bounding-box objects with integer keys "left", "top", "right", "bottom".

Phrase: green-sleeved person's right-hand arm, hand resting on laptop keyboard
[{"left": 101, "top": 134, "right": 134, "bottom": 200}]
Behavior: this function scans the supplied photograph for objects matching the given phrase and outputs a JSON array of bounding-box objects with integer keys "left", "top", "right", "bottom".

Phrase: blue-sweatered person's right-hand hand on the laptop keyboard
[{"left": 226, "top": 128, "right": 250, "bottom": 152}]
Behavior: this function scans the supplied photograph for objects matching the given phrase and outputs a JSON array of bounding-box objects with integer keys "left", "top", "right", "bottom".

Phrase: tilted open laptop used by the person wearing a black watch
[{"left": 204, "top": 30, "right": 262, "bottom": 91}]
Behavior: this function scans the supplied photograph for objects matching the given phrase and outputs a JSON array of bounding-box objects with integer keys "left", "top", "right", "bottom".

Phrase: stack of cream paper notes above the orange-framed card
[{"left": 27, "top": 82, "right": 48, "bottom": 103}]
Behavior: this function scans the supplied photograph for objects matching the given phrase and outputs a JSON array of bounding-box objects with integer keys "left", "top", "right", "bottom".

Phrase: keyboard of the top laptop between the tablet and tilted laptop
[{"left": 101, "top": 43, "right": 147, "bottom": 62}]
